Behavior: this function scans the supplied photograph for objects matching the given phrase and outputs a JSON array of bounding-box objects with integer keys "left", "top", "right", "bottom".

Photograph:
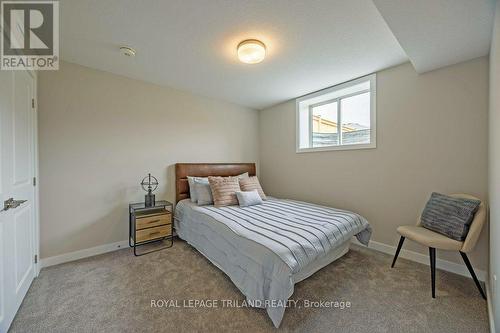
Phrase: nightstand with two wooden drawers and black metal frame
[{"left": 128, "top": 200, "right": 174, "bottom": 256}]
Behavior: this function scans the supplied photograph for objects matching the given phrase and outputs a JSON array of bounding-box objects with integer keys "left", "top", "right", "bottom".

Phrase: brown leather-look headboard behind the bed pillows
[{"left": 175, "top": 163, "right": 256, "bottom": 203}]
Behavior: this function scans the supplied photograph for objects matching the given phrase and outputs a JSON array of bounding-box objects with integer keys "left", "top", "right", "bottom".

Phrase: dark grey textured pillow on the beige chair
[{"left": 421, "top": 192, "right": 481, "bottom": 242}]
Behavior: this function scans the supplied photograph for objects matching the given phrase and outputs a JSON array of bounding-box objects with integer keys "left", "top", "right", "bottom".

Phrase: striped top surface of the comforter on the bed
[{"left": 196, "top": 198, "right": 371, "bottom": 273}]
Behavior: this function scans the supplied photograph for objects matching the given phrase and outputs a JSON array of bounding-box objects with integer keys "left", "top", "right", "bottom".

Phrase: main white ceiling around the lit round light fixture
[{"left": 60, "top": 0, "right": 408, "bottom": 109}]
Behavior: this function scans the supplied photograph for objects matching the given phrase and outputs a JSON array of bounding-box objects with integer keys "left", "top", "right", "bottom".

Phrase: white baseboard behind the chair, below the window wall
[{"left": 352, "top": 238, "right": 487, "bottom": 282}]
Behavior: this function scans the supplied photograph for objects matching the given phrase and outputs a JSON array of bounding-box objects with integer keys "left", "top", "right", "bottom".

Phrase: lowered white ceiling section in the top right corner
[{"left": 373, "top": 0, "right": 495, "bottom": 73}]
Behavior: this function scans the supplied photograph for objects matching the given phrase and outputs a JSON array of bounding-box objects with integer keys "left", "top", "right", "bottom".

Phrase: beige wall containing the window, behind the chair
[{"left": 259, "top": 58, "right": 488, "bottom": 270}]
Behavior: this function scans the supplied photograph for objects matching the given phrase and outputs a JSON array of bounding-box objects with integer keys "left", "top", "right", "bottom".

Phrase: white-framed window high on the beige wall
[{"left": 296, "top": 74, "right": 376, "bottom": 153}]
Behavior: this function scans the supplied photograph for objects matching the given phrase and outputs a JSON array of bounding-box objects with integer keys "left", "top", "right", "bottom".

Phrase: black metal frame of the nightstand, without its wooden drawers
[{"left": 128, "top": 200, "right": 174, "bottom": 257}]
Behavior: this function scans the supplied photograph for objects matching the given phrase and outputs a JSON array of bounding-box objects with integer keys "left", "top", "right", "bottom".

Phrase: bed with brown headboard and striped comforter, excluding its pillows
[{"left": 174, "top": 163, "right": 371, "bottom": 327}]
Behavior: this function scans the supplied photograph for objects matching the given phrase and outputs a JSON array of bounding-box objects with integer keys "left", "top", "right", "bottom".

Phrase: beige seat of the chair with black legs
[{"left": 397, "top": 225, "right": 464, "bottom": 251}]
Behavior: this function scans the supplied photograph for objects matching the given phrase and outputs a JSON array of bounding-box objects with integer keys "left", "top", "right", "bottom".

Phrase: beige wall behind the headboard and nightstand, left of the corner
[{"left": 38, "top": 63, "right": 258, "bottom": 258}]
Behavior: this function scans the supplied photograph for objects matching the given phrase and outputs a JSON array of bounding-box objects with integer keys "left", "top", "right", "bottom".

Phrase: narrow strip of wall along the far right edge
[{"left": 489, "top": 1, "right": 500, "bottom": 326}]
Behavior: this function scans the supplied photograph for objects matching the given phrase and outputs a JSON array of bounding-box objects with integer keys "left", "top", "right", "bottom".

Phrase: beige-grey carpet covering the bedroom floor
[{"left": 11, "top": 240, "right": 488, "bottom": 333}]
